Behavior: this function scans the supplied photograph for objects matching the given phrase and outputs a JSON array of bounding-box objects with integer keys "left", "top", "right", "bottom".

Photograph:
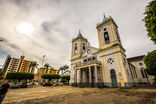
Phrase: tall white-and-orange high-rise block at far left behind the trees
[{"left": 2, "top": 55, "right": 35, "bottom": 75}]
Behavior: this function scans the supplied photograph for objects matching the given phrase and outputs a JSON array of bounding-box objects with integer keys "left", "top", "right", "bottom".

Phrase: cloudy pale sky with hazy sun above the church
[{"left": 0, "top": 0, "right": 156, "bottom": 68}]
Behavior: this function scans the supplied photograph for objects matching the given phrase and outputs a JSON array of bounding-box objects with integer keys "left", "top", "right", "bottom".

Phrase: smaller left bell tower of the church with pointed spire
[{"left": 71, "top": 30, "right": 88, "bottom": 59}]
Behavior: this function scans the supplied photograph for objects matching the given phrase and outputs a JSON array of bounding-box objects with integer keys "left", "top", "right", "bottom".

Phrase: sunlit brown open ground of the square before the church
[{"left": 2, "top": 86, "right": 156, "bottom": 104}]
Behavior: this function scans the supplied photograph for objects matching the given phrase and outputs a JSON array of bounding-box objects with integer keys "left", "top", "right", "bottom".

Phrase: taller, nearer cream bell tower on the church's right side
[{"left": 96, "top": 15, "right": 122, "bottom": 49}]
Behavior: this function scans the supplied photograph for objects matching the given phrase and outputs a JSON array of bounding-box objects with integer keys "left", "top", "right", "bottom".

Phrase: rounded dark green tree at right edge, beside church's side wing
[{"left": 144, "top": 50, "right": 156, "bottom": 76}]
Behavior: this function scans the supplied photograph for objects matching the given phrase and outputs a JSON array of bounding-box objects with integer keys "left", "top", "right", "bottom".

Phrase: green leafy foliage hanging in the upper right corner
[{"left": 143, "top": 0, "right": 156, "bottom": 44}]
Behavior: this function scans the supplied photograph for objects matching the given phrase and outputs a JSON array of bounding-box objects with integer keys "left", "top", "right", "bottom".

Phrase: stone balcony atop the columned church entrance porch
[{"left": 76, "top": 60, "right": 101, "bottom": 67}]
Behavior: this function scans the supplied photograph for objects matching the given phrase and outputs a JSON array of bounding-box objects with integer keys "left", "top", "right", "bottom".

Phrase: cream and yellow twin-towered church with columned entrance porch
[{"left": 70, "top": 16, "right": 152, "bottom": 88}]
